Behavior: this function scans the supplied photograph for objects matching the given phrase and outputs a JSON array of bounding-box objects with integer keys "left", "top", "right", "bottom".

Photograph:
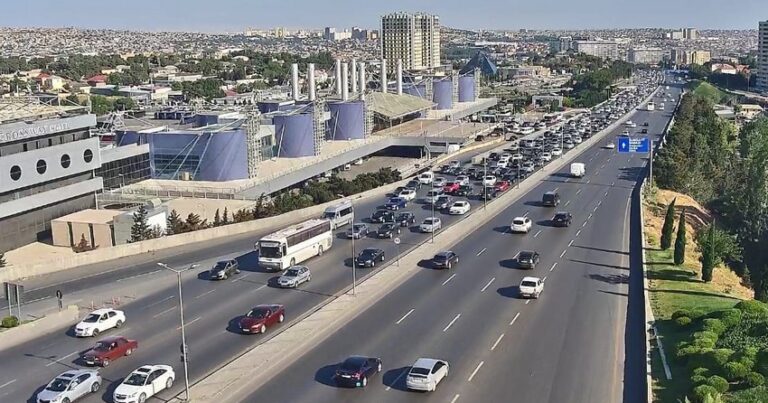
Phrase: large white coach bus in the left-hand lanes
[{"left": 255, "top": 218, "right": 333, "bottom": 270}]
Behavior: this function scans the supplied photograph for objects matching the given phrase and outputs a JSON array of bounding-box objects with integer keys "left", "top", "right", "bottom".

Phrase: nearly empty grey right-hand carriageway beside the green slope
[{"left": 245, "top": 80, "right": 679, "bottom": 403}]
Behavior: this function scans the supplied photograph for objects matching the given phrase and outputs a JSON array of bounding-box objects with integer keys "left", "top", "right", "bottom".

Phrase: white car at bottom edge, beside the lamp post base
[{"left": 112, "top": 365, "right": 176, "bottom": 403}]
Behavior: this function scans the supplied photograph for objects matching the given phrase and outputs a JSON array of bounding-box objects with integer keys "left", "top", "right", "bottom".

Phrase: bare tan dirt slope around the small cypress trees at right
[{"left": 643, "top": 189, "right": 754, "bottom": 299}]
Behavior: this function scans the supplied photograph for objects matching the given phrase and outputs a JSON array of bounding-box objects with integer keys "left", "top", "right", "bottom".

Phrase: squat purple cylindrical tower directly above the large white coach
[{"left": 274, "top": 113, "right": 315, "bottom": 158}]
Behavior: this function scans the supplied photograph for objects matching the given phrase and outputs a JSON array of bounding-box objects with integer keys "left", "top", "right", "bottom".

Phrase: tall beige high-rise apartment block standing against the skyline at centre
[{"left": 381, "top": 13, "right": 440, "bottom": 72}]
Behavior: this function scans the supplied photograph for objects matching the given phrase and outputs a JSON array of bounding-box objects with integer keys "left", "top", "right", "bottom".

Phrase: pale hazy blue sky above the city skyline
[{"left": 0, "top": 0, "right": 768, "bottom": 31}]
